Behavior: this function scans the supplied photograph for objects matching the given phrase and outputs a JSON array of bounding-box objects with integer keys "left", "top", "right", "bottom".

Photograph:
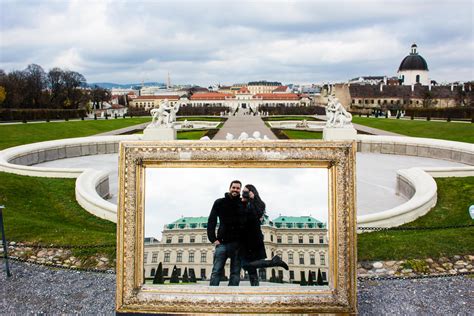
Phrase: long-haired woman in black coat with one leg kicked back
[{"left": 239, "top": 184, "right": 288, "bottom": 286}]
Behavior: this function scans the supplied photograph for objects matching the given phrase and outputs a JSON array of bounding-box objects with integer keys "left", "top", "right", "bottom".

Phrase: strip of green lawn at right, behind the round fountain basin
[{"left": 352, "top": 116, "right": 474, "bottom": 143}]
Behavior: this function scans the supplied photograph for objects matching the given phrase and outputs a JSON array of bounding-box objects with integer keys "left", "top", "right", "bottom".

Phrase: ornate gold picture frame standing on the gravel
[{"left": 116, "top": 140, "right": 357, "bottom": 313}]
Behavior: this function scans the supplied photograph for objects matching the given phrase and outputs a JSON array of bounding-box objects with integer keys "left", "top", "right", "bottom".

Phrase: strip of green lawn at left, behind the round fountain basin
[{"left": 0, "top": 117, "right": 151, "bottom": 150}]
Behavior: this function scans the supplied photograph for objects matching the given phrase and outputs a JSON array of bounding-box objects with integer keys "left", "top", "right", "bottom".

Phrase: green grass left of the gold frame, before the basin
[{"left": 0, "top": 172, "right": 116, "bottom": 245}]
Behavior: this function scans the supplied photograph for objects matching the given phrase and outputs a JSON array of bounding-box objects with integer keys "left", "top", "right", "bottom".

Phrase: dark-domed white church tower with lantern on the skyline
[{"left": 397, "top": 44, "right": 430, "bottom": 86}]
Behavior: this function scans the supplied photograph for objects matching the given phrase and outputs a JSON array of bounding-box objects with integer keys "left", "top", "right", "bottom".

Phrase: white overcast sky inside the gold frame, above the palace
[{"left": 145, "top": 168, "right": 328, "bottom": 239}]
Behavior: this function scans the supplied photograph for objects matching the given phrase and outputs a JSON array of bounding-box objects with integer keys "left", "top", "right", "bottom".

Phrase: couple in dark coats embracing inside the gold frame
[{"left": 207, "top": 180, "right": 288, "bottom": 286}]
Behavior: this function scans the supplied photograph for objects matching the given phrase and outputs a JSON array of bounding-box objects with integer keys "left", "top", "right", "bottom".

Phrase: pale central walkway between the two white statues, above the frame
[{"left": 213, "top": 113, "right": 278, "bottom": 140}]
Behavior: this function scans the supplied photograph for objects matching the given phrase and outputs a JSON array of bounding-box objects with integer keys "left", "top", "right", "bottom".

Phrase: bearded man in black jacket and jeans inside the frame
[{"left": 207, "top": 180, "right": 243, "bottom": 286}]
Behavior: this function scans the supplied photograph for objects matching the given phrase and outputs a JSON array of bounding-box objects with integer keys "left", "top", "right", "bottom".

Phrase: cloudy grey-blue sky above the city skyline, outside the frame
[{"left": 0, "top": 0, "right": 474, "bottom": 85}]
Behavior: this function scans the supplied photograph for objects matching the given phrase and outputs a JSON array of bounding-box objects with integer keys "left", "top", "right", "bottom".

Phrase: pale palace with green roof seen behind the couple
[{"left": 144, "top": 216, "right": 329, "bottom": 282}]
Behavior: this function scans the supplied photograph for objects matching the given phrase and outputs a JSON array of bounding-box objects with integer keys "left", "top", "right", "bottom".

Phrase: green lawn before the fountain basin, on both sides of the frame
[{"left": 0, "top": 172, "right": 474, "bottom": 261}]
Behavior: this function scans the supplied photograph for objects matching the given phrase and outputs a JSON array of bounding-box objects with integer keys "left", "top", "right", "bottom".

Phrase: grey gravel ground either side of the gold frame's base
[{"left": 0, "top": 260, "right": 474, "bottom": 315}]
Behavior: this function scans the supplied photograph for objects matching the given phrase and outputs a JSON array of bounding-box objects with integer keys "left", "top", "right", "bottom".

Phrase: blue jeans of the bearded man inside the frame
[{"left": 209, "top": 242, "right": 240, "bottom": 286}]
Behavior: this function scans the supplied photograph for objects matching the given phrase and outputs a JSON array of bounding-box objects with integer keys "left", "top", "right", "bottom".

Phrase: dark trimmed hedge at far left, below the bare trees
[{"left": 0, "top": 109, "right": 87, "bottom": 122}]
